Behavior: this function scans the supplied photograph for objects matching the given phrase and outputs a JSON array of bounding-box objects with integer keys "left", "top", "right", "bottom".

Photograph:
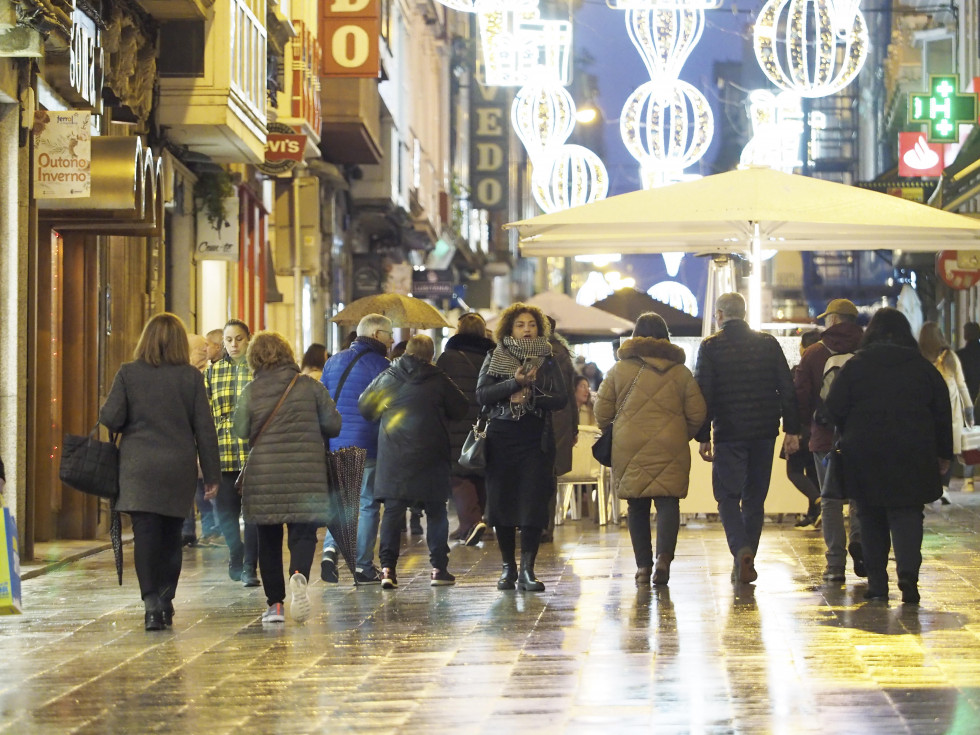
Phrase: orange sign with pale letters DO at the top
[{"left": 319, "top": 0, "right": 381, "bottom": 78}]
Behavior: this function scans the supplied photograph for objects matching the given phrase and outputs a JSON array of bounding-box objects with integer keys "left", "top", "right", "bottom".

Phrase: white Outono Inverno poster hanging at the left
[{"left": 33, "top": 110, "right": 92, "bottom": 199}]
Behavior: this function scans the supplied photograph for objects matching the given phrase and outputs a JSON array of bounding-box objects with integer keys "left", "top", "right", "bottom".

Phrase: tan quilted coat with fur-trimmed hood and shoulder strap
[{"left": 595, "top": 337, "right": 707, "bottom": 498}]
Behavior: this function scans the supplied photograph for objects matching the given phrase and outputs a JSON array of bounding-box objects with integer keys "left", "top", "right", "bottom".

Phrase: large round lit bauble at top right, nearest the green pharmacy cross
[{"left": 754, "top": 0, "right": 868, "bottom": 97}]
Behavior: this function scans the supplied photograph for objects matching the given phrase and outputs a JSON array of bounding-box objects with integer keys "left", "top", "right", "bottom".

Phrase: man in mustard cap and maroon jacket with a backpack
[{"left": 794, "top": 299, "right": 867, "bottom": 582}]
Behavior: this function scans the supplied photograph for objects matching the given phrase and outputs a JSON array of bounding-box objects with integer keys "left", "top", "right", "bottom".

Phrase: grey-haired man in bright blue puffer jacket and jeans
[{"left": 320, "top": 314, "right": 394, "bottom": 585}]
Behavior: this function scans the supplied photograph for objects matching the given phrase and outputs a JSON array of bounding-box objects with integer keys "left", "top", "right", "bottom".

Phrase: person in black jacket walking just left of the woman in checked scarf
[{"left": 436, "top": 314, "right": 494, "bottom": 546}]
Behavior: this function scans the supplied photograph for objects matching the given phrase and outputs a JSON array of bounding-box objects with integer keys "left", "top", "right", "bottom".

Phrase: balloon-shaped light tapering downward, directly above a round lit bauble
[{"left": 626, "top": 8, "right": 704, "bottom": 79}]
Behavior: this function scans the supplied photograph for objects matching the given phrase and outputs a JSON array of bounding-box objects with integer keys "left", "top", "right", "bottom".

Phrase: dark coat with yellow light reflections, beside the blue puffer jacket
[{"left": 357, "top": 355, "right": 469, "bottom": 503}]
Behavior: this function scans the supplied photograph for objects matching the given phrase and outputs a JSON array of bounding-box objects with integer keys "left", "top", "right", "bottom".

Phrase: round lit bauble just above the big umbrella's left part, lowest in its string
[{"left": 531, "top": 145, "right": 609, "bottom": 212}]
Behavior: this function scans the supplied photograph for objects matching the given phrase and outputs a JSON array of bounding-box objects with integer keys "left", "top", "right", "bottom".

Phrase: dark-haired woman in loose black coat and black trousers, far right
[{"left": 826, "top": 308, "right": 953, "bottom": 604}]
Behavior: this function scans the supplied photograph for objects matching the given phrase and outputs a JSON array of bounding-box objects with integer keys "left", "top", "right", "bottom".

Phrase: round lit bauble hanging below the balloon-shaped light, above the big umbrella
[{"left": 619, "top": 79, "right": 714, "bottom": 171}]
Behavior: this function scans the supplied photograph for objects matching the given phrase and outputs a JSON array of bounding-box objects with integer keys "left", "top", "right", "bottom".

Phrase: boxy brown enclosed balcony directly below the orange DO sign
[{"left": 320, "top": 77, "right": 382, "bottom": 164}]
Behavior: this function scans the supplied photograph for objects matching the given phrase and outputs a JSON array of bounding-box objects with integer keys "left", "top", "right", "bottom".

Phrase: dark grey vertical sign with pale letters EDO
[{"left": 470, "top": 80, "right": 511, "bottom": 210}]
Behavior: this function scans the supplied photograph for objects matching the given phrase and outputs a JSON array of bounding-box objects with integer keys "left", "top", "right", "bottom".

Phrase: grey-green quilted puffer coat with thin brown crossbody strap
[{"left": 234, "top": 364, "right": 341, "bottom": 525}]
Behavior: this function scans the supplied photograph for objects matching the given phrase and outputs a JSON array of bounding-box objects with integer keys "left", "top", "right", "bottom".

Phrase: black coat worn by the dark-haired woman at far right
[{"left": 826, "top": 343, "right": 953, "bottom": 508}]
